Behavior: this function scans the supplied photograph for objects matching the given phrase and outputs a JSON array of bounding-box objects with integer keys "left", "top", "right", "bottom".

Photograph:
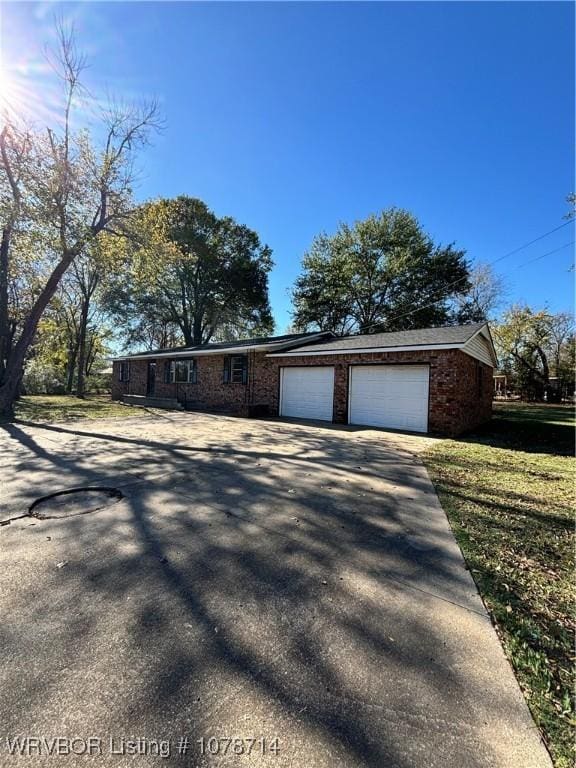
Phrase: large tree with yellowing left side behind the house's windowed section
[{"left": 107, "top": 196, "right": 274, "bottom": 346}]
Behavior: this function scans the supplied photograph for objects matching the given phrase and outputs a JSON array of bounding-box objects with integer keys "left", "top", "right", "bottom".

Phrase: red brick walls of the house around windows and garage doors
[{"left": 112, "top": 350, "right": 492, "bottom": 435}]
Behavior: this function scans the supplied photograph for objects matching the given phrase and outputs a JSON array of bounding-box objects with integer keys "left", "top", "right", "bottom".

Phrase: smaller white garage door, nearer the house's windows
[{"left": 280, "top": 366, "right": 334, "bottom": 421}]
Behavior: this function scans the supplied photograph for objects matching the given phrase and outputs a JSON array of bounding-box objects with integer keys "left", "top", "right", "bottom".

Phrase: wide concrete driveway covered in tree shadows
[{"left": 0, "top": 411, "right": 550, "bottom": 768}]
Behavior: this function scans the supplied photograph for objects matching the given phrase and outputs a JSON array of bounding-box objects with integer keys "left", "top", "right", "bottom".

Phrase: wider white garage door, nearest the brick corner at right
[{"left": 349, "top": 365, "right": 429, "bottom": 432}]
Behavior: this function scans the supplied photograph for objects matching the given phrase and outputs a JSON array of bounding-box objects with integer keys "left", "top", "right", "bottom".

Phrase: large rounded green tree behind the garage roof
[{"left": 293, "top": 208, "right": 469, "bottom": 333}]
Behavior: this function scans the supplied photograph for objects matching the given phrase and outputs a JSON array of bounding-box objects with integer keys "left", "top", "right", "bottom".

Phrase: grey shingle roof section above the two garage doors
[{"left": 272, "top": 323, "right": 486, "bottom": 354}]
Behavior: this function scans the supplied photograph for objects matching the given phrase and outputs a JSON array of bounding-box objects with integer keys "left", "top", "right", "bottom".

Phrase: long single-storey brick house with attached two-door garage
[{"left": 112, "top": 323, "right": 496, "bottom": 435}]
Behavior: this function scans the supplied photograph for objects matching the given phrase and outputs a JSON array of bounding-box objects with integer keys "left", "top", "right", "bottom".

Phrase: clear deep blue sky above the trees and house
[{"left": 1, "top": 2, "right": 575, "bottom": 332}]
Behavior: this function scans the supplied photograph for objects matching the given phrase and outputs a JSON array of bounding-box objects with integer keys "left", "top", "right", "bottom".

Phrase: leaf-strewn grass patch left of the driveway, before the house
[{"left": 15, "top": 395, "right": 147, "bottom": 422}]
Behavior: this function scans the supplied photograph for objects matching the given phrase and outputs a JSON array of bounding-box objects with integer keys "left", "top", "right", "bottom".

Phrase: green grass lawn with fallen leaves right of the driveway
[{"left": 424, "top": 403, "right": 576, "bottom": 768}]
